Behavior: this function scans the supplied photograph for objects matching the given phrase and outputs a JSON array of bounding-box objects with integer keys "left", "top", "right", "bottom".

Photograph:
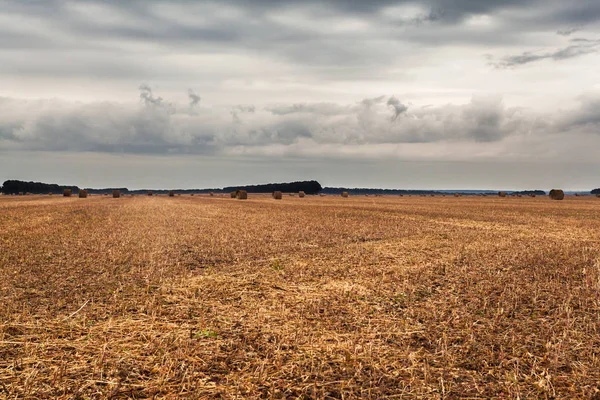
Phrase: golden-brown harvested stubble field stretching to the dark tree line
[{"left": 0, "top": 195, "right": 600, "bottom": 399}]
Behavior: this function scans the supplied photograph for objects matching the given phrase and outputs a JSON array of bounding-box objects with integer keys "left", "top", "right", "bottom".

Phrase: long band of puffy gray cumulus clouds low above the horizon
[{"left": 0, "top": 89, "right": 600, "bottom": 154}]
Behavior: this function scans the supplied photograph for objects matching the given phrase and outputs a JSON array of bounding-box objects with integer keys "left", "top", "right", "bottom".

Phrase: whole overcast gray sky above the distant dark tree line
[{"left": 0, "top": 0, "right": 600, "bottom": 190}]
